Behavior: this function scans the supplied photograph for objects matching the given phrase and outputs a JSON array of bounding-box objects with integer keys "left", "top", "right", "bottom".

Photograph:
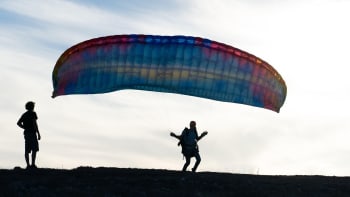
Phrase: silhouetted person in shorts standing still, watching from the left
[{"left": 17, "top": 101, "right": 41, "bottom": 169}]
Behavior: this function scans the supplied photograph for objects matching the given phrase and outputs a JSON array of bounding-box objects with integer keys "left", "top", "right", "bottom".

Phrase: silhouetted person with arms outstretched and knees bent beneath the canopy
[{"left": 170, "top": 121, "right": 208, "bottom": 172}]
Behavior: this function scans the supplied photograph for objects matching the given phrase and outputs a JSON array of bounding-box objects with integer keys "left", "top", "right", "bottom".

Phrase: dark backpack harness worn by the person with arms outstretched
[{"left": 180, "top": 127, "right": 198, "bottom": 156}]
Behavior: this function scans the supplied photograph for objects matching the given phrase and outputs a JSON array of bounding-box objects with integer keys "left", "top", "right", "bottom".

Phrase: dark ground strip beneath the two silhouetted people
[{"left": 0, "top": 167, "right": 350, "bottom": 197}]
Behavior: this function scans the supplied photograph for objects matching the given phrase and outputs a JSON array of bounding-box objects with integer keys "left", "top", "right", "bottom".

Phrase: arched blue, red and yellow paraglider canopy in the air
[{"left": 52, "top": 35, "right": 287, "bottom": 112}]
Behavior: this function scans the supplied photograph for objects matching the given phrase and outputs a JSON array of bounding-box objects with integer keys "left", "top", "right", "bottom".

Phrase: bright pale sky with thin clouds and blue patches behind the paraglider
[{"left": 0, "top": 0, "right": 350, "bottom": 176}]
